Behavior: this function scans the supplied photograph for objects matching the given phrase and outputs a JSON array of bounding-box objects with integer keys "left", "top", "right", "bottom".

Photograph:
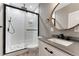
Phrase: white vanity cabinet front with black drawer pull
[{"left": 39, "top": 40, "right": 70, "bottom": 56}]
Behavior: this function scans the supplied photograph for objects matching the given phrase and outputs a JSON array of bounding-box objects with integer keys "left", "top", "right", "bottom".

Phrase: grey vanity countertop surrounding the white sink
[{"left": 39, "top": 37, "right": 79, "bottom": 56}]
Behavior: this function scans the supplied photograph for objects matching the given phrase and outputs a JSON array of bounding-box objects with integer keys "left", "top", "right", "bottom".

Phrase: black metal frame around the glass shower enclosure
[{"left": 3, "top": 4, "right": 39, "bottom": 55}]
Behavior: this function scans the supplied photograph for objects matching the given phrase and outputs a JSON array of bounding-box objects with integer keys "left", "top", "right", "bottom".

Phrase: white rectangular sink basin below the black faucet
[{"left": 48, "top": 38, "right": 73, "bottom": 46}]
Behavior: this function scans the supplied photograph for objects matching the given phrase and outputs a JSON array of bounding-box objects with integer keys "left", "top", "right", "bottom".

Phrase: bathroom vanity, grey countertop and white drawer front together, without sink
[{"left": 39, "top": 38, "right": 79, "bottom": 56}]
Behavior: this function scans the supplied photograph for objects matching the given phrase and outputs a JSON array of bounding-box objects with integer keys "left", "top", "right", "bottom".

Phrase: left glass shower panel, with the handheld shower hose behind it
[{"left": 5, "top": 7, "right": 25, "bottom": 53}]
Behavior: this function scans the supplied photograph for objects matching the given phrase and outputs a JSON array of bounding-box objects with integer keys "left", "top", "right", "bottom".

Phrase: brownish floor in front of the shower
[{"left": 4, "top": 47, "right": 39, "bottom": 56}]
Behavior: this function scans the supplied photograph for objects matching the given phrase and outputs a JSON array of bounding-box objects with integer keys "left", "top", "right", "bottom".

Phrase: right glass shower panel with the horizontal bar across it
[{"left": 25, "top": 12, "right": 38, "bottom": 48}]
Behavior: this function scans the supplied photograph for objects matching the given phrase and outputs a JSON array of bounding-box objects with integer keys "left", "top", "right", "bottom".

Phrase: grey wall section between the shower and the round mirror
[{"left": 39, "top": 3, "right": 56, "bottom": 37}]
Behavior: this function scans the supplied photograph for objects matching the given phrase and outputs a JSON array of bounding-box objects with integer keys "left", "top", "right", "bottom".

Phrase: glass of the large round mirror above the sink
[{"left": 52, "top": 3, "right": 79, "bottom": 32}]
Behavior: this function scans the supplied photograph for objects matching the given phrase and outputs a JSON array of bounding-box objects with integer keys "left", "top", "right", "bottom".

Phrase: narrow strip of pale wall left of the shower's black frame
[{"left": 0, "top": 3, "right": 3, "bottom": 55}]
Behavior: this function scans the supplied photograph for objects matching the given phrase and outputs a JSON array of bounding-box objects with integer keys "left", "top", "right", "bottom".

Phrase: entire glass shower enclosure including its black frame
[{"left": 3, "top": 4, "right": 39, "bottom": 54}]
